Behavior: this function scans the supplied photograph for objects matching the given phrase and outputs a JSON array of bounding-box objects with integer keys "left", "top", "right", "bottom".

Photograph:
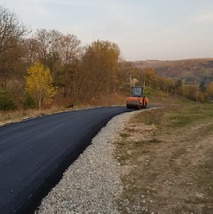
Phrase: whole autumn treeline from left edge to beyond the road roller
[{"left": 0, "top": 6, "right": 211, "bottom": 110}]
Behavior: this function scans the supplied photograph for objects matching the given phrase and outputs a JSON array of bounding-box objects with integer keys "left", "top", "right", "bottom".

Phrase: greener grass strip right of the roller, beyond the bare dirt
[{"left": 131, "top": 101, "right": 213, "bottom": 129}]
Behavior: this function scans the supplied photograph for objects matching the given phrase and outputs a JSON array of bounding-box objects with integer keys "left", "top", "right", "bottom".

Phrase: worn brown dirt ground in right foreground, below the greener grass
[{"left": 116, "top": 108, "right": 213, "bottom": 214}]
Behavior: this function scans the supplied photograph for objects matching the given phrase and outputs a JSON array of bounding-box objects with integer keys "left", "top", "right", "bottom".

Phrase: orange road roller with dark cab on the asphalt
[{"left": 126, "top": 86, "right": 148, "bottom": 109}]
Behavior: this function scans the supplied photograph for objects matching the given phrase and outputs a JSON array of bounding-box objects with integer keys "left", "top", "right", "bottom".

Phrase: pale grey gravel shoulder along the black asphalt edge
[{"left": 36, "top": 112, "right": 134, "bottom": 214}]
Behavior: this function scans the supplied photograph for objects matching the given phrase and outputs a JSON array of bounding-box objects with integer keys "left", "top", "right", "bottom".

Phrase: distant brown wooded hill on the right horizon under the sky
[{"left": 133, "top": 58, "right": 213, "bottom": 84}]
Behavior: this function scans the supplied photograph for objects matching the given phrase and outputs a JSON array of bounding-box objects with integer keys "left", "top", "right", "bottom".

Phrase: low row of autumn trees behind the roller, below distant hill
[{"left": 132, "top": 67, "right": 213, "bottom": 102}]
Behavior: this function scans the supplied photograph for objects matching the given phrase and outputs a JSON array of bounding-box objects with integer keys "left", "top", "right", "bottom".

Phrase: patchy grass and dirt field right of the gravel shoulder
[{"left": 116, "top": 98, "right": 213, "bottom": 214}]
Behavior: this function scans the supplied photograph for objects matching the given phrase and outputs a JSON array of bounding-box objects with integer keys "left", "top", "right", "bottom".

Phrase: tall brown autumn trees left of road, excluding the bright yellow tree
[{"left": 0, "top": 7, "right": 128, "bottom": 110}]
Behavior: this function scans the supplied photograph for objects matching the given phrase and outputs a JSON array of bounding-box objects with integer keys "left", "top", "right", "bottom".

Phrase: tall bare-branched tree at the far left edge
[{"left": 0, "top": 6, "right": 28, "bottom": 89}]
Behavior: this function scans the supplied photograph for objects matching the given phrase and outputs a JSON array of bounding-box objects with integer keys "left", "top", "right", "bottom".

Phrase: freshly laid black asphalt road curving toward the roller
[{"left": 0, "top": 107, "right": 131, "bottom": 214}]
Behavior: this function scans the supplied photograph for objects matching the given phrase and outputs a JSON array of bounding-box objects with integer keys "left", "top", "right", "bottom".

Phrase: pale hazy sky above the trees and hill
[{"left": 0, "top": 0, "right": 213, "bottom": 61}]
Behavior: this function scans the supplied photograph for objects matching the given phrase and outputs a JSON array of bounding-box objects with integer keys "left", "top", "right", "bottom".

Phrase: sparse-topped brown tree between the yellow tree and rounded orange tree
[{"left": 31, "top": 29, "right": 82, "bottom": 97}]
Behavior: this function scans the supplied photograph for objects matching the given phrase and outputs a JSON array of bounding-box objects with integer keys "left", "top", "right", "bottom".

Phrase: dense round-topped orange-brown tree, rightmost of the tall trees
[{"left": 78, "top": 40, "right": 120, "bottom": 100}]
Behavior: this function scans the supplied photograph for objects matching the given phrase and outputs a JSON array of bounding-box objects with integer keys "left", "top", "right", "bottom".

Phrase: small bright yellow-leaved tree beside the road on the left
[{"left": 25, "top": 62, "right": 56, "bottom": 110}]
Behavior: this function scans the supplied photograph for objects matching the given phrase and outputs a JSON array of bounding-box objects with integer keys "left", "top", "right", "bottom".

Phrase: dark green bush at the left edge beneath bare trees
[{"left": 0, "top": 92, "right": 16, "bottom": 111}]
